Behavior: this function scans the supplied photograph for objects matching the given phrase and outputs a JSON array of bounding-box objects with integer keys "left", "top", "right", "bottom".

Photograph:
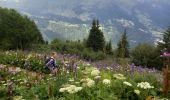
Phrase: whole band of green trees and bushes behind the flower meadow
[{"left": 0, "top": 8, "right": 170, "bottom": 67}]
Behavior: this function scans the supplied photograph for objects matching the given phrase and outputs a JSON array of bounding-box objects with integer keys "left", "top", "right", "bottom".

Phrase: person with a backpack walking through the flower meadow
[{"left": 45, "top": 52, "right": 58, "bottom": 75}]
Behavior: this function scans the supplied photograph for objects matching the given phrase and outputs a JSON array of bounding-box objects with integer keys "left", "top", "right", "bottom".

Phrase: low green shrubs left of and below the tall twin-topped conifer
[{"left": 50, "top": 39, "right": 106, "bottom": 61}]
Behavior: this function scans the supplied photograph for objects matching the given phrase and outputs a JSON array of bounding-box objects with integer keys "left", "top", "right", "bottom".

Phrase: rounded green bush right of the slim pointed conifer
[{"left": 131, "top": 43, "right": 162, "bottom": 69}]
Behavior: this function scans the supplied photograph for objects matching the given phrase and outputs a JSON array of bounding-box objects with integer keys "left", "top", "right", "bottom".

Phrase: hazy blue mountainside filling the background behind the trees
[{"left": 0, "top": 0, "right": 170, "bottom": 47}]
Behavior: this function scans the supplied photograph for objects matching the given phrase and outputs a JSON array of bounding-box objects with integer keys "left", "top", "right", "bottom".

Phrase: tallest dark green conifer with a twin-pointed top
[{"left": 86, "top": 19, "right": 105, "bottom": 52}]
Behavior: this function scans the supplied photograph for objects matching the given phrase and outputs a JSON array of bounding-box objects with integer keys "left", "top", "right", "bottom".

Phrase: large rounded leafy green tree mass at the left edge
[{"left": 0, "top": 8, "right": 44, "bottom": 49}]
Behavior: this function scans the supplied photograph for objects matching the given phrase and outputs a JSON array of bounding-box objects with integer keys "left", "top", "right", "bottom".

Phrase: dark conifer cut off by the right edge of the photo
[{"left": 158, "top": 27, "right": 170, "bottom": 52}]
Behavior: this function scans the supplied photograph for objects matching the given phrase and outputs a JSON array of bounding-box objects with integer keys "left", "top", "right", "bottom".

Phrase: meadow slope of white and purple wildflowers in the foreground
[{"left": 0, "top": 52, "right": 168, "bottom": 100}]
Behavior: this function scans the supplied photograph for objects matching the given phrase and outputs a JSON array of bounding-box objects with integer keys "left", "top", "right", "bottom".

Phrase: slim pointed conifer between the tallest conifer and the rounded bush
[{"left": 117, "top": 29, "right": 129, "bottom": 58}]
